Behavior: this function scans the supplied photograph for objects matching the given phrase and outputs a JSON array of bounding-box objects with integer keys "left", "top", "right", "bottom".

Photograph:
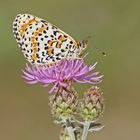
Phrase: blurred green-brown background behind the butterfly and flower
[{"left": 0, "top": 0, "right": 140, "bottom": 140}]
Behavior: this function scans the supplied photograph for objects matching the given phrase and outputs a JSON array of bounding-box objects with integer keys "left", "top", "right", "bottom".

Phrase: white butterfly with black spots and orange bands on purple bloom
[{"left": 13, "top": 14, "right": 87, "bottom": 65}]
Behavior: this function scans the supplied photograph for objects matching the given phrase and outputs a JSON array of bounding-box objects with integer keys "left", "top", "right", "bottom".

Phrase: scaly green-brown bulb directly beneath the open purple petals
[{"left": 49, "top": 89, "right": 78, "bottom": 120}]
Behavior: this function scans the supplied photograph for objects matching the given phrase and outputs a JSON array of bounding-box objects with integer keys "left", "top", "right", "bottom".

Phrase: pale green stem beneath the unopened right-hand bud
[{"left": 81, "top": 121, "right": 90, "bottom": 140}]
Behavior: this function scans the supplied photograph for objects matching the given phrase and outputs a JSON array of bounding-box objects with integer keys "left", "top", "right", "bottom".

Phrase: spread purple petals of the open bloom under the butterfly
[{"left": 23, "top": 59, "right": 102, "bottom": 93}]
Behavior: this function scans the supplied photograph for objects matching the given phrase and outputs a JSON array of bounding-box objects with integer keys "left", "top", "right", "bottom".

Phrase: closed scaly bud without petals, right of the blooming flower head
[{"left": 79, "top": 86, "right": 104, "bottom": 121}]
